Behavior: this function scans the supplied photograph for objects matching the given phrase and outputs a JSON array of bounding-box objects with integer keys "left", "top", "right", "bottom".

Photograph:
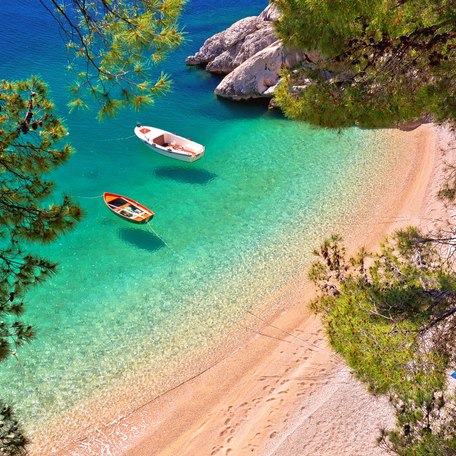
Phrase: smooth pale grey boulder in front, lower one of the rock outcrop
[{"left": 215, "top": 40, "right": 306, "bottom": 100}]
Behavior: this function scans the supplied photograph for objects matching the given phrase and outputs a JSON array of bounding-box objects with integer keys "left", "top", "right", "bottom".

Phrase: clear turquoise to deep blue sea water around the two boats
[{"left": 0, "top": 0, "right": 396, "bottom": 448}]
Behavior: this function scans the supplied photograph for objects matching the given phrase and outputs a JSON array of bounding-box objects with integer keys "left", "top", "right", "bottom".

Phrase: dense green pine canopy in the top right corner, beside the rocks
[{"left": 274, "top": 0, "right": 456, "bottom": 128}]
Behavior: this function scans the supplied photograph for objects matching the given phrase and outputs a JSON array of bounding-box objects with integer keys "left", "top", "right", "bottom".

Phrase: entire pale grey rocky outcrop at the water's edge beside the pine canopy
[{"left": 185, "top": 5, "right": 306, "bottom": 99}]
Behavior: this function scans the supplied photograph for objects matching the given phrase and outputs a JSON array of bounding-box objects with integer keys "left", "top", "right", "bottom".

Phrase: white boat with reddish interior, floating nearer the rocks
[{"left": 135, "top": 125, "right": 205, "bottom": 162}]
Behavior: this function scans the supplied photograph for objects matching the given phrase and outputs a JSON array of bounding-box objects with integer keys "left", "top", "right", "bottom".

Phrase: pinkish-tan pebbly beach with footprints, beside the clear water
[{"left": 122, "top": 125, "right": 443, "bottom": 456}]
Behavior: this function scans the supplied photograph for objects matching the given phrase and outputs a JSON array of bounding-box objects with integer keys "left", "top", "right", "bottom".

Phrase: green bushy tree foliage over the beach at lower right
[{"left": 309, "top": 228, "right": 456, "bottom": 455}]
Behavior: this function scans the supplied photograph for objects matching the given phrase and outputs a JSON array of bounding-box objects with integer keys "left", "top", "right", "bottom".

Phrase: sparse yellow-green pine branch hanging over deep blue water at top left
[{"left": 45, "top": 0, "right": 185, "bottom": 118}]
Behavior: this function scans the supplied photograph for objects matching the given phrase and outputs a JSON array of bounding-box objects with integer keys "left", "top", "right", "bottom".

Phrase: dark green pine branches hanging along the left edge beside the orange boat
[{"left": 0, "top": 77, "right": 81, "bottom": 361}]
